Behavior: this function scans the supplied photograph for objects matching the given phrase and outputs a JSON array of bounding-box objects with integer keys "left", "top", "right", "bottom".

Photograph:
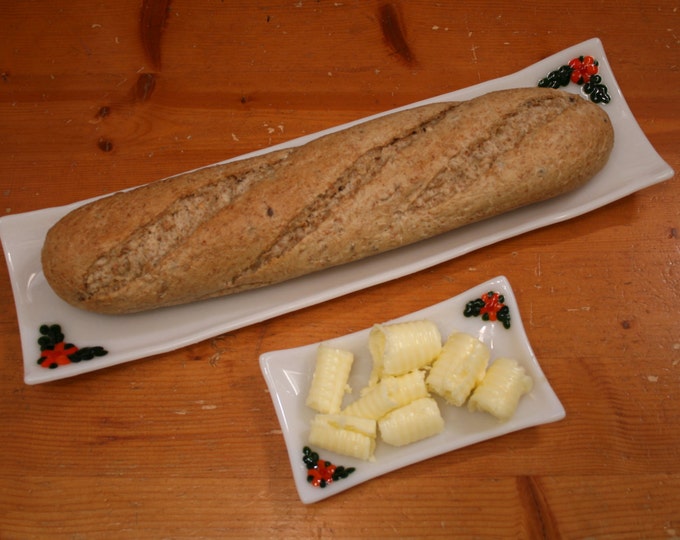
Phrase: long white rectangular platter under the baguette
[{"left": 0, "top": 38, "right": 673, "bottom": 384}]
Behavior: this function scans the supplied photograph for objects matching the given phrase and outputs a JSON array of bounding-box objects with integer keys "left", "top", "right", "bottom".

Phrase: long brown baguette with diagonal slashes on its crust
[{"left": 42, "top": 88, "right": 614, "bottom": 314}]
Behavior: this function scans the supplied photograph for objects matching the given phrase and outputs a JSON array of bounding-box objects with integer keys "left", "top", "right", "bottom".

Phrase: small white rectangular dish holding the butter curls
[{"left": 260, "top": 276, "right": 565, "bottom": 503}]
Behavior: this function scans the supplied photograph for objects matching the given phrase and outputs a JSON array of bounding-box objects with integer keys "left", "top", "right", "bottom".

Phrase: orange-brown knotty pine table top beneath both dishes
[{"left": 0, "top": 0, "right": 680, "bottom": 539}]
